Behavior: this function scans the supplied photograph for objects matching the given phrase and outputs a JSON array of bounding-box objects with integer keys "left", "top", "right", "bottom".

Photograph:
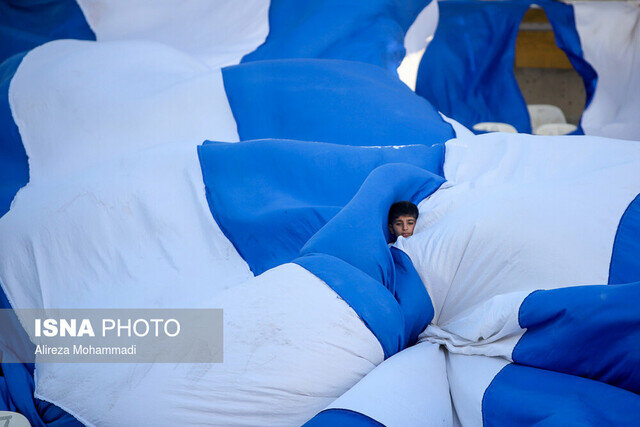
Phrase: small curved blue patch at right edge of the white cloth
[{"left": 609, "top": 194, "right": 640, "bottom": 284}]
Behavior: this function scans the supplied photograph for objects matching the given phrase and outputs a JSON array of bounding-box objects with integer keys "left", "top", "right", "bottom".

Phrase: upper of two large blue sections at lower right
[{"left": 512, "top": 283, "right": 640, "bottom": 394}]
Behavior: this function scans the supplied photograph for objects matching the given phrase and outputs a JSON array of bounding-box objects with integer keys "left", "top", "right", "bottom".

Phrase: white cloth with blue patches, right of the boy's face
[{"left": 396, "top": 134, "right": 640, "bottom": 425}]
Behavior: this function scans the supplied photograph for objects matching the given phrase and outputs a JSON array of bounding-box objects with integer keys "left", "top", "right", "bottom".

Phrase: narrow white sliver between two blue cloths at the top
[{"left": 398, "top": 0, "right": 439, "bottom": 91}]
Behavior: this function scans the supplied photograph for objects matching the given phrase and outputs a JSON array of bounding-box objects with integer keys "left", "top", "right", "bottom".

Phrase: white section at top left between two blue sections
[{"left": 77, "top": 0, "right": 270, "bottom": 68}]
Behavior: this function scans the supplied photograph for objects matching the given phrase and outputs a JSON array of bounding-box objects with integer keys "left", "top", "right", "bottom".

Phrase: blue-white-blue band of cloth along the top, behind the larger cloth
[{"left": 0, "top": 0, "right": 440, "bottom": 72}]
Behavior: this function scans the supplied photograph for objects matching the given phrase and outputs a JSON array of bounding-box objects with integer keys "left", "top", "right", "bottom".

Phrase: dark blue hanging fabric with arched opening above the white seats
[{"left": 416, "top": 0, "right": 597, "bottom": 134}]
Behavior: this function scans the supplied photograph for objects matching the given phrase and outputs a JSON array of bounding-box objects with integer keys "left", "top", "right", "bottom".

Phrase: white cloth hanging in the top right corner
[{"left": 573, "top": 1, "right": 640, "bottom": 141}]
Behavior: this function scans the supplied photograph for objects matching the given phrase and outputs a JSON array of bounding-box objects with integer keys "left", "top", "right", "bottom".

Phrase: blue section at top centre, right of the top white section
[{"left": 242, "top": 0, "right": 430, "bottom": 72}]
